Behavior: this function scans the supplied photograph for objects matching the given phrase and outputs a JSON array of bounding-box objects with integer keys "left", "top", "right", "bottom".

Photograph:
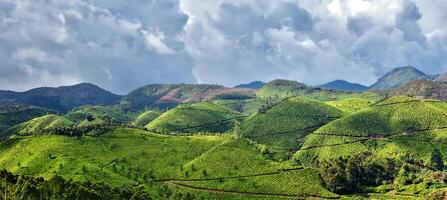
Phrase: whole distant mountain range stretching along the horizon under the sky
[{"left": 0, "top": 66, "right": 447, "bottom": 113}]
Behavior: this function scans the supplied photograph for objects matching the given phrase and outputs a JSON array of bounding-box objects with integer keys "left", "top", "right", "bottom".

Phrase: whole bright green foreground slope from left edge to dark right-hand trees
[{"left": 0, "top": 128, "right": 337, "bottom": 199}]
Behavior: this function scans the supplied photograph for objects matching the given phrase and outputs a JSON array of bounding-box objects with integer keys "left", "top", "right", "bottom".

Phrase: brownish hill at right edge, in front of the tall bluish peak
[{"left": 388, "top": 80, "right": 447, "bottom": 100}]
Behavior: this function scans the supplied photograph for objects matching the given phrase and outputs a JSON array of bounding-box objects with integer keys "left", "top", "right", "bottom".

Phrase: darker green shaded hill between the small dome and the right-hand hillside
[{"left": 240, "top": 97, "right": 342, "bottom": 159}]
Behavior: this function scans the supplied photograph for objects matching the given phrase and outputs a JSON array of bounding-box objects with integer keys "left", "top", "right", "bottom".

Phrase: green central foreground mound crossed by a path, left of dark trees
[{"left": 166, "top": 139, "right": 337, "bottom": 199}]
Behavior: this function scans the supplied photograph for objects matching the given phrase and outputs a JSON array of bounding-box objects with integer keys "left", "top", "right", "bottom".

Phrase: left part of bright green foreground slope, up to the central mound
[{"left": 0, "top": 128, "right": 227, "bottom": 186}]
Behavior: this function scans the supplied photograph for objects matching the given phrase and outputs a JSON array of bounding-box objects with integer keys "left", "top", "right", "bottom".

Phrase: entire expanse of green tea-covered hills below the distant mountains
[{"left": 4, "top": 92, "right": 447, "bottom": 199}]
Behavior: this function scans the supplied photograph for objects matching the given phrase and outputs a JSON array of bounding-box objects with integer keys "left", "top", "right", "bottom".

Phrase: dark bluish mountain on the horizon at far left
[{"left": 0, "top": 83, "right": 121, "bottom": 113}]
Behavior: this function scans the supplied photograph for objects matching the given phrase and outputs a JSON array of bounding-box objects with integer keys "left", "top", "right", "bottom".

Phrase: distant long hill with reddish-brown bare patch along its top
[{"left": 122, "top": 84, "right": 254, "bottom": 110}]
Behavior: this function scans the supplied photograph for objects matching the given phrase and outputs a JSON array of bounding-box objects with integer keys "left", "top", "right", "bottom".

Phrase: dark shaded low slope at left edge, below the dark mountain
[{"left": 0, "top": 104, "right": 54, "bottom": 133}]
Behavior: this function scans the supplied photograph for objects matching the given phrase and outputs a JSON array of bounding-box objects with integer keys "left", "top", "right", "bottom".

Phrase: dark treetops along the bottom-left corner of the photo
[{"left": 0, "top": 170, "right": 153, "bottom": 200}]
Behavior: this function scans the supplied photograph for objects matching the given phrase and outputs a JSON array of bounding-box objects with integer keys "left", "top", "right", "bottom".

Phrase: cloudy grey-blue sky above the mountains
[{"left": 0, "top": 0, "right": 447, "bottom": 94}]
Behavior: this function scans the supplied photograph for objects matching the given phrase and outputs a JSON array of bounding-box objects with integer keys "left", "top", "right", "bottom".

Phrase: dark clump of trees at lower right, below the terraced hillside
[{"left": 320, "top": 149, "right": 447, "bottom": 194}]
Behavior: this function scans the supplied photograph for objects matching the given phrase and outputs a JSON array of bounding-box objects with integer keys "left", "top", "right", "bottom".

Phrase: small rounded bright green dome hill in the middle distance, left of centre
[{"left": 146, "top": 102, "right": 241, "bottom": 133}]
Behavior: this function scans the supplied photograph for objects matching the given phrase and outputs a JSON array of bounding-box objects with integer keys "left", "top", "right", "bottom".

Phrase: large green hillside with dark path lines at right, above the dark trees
[{"left": 294, "top": 96, "right": 447, "bottom": 164}]
